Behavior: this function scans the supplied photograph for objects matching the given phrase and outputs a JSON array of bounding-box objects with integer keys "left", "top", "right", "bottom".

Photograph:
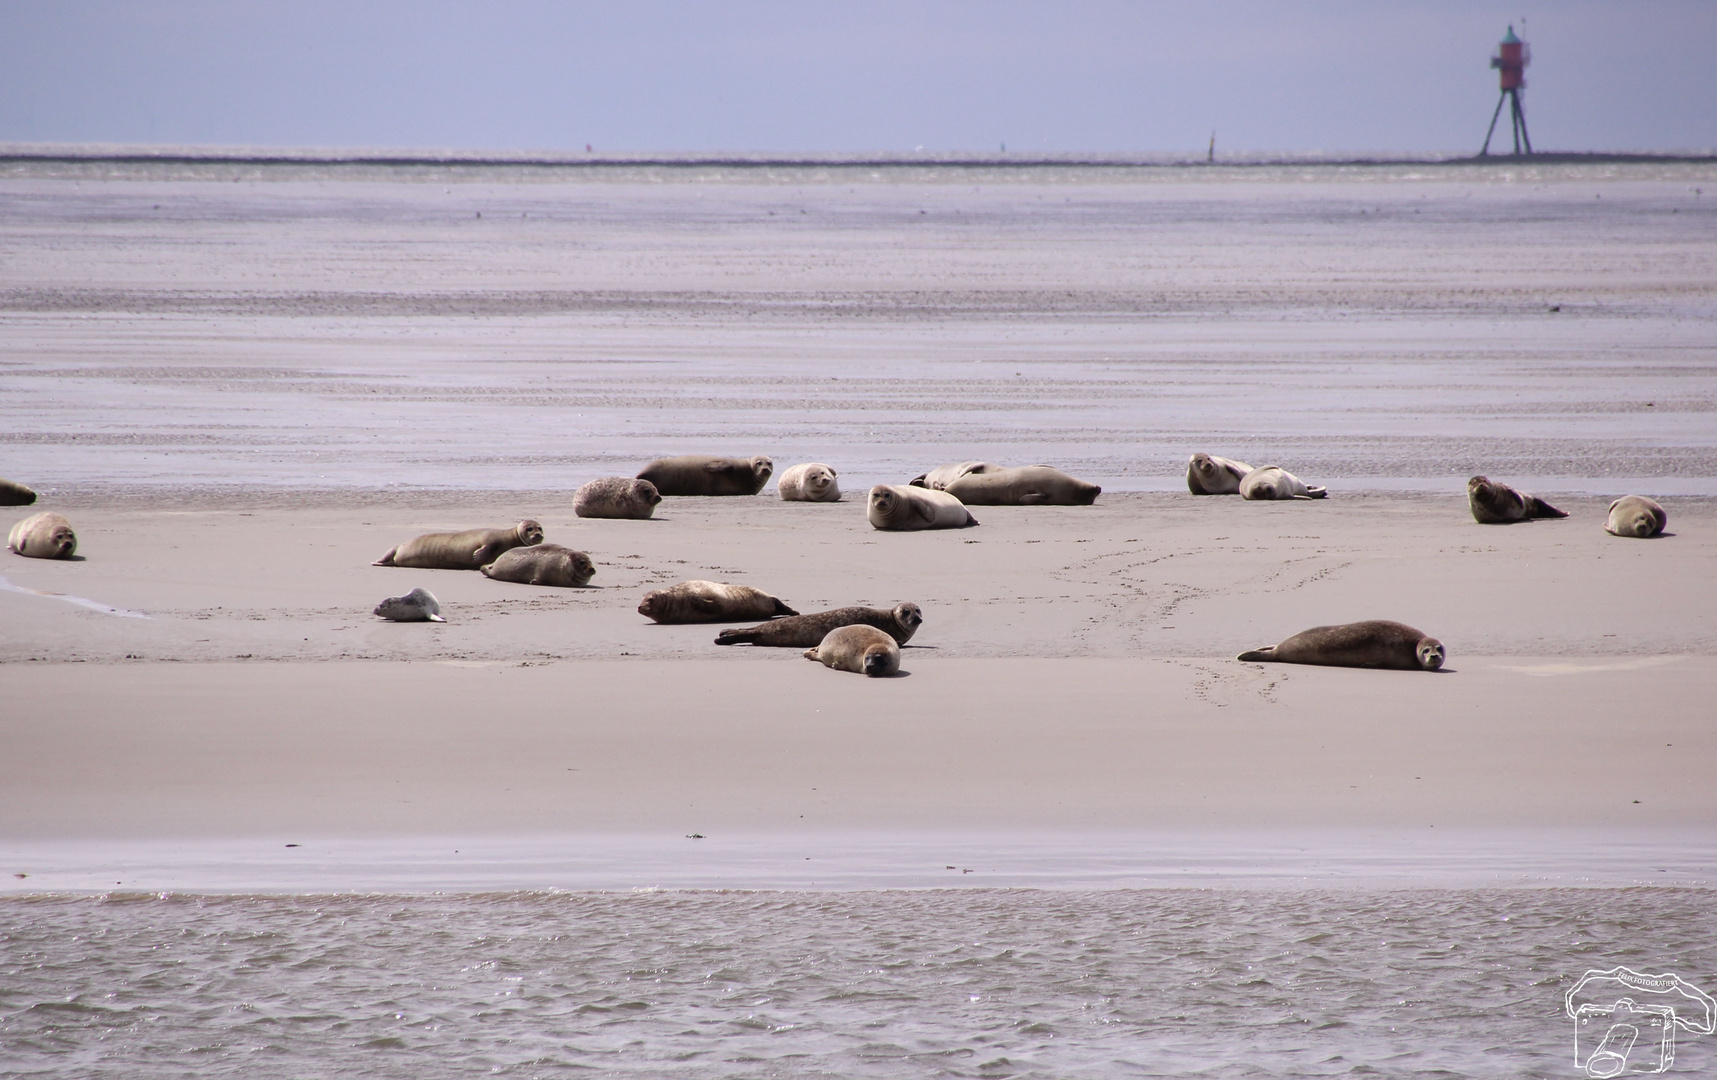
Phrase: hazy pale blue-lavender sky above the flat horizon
[{"left": 0, "top": 0, "right": 1717, "bottom": 153}]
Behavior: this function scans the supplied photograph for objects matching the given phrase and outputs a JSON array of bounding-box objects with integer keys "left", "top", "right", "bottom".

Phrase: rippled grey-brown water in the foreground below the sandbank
[{"left": 0, "top": 889, "right": 1717, "bottom": 1077}]
